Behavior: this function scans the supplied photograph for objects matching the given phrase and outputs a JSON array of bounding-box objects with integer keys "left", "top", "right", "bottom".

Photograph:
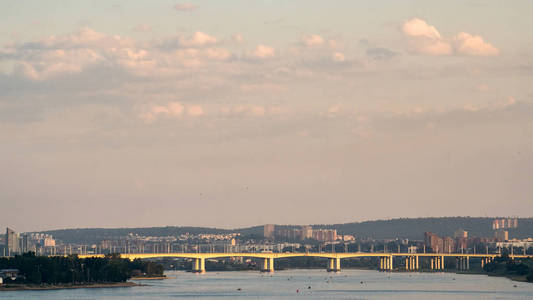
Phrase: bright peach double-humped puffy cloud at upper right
[{"left": 401, "top": 18, "right": 500, "bottom": 56}]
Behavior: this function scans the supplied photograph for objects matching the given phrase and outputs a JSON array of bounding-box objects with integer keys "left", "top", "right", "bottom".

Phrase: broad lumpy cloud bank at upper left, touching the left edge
[{"left": 0, "top": 28, "right": 164, "bottom": 80}]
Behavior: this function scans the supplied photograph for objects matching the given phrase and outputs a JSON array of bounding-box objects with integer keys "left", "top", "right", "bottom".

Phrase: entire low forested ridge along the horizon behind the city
[{"left": 39, "top": 217, "right": 533, "bottom": 243}]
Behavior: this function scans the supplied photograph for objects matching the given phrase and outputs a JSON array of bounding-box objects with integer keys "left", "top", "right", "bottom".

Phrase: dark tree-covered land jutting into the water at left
[{"left": 0, "top": 252, "right": 165, "bottom": 291}]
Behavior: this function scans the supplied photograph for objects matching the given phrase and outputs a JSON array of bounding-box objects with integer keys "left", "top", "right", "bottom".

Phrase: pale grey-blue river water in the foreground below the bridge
[{"left": 0, "top": 270, "right": 533, "bottom": 300}]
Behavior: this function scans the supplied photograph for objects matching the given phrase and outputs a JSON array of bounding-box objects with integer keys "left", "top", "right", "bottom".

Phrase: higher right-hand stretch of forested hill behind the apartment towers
[{"left": 313, "top": 217, "right": 533, "bottom": 240}]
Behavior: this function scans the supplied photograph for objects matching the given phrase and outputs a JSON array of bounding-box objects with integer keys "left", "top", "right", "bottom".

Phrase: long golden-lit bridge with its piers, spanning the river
[{"left": 78, "top": 252, "right": 533, "bottom": 273}]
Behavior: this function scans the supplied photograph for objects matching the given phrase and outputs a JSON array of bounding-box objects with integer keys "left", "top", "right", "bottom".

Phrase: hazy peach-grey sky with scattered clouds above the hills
[{"left": 0, "top": 0, "right": 533, "bottom": 231}]
